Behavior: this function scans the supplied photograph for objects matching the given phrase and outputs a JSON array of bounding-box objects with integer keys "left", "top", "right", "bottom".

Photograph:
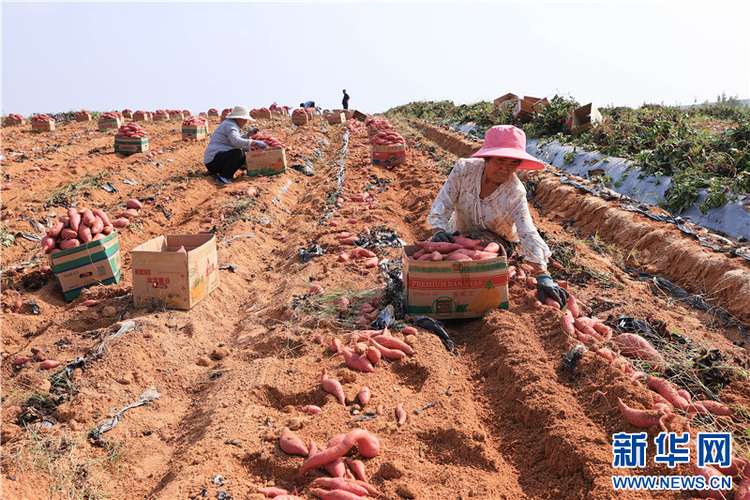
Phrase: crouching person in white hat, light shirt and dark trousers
[{"left": 203, "top": 106, "right": 266, "bottom": 184}]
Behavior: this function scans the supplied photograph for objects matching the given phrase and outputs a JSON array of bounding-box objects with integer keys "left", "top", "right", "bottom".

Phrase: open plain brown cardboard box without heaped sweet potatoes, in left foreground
[{"left": 130, "top": 234, "right": 219, "bottom": 310}]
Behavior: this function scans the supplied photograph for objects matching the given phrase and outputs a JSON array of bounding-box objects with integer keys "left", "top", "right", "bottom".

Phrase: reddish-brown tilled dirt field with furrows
[{"left": 2, "top": 114, "right": 750, "bottom": 500}]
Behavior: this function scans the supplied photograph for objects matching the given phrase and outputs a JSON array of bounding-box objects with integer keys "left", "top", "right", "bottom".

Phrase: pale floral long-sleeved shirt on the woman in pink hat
[{"left": 427, "top": 158, "right": 552, "bottom": 265}]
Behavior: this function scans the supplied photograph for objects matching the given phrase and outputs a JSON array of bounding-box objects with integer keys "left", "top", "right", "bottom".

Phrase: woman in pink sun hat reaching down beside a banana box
[{"left": 427, "top": 125, "right": 568, "bottom": 306}]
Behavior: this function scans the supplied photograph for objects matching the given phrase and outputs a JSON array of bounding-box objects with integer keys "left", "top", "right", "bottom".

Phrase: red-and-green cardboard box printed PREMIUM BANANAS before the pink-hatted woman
[{"left": 402, "top": 245, "right": 510, "bottom": 319}]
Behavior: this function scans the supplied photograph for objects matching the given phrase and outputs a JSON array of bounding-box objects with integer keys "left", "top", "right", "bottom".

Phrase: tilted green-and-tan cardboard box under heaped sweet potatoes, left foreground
[{"left": 49, "top": 231, "right": 122, "bottom": 300}]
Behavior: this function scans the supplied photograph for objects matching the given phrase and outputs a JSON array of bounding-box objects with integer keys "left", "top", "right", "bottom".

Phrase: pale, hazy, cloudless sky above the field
[{"left": 0, "top": 0, "right": 750, "bottom": 116}]
